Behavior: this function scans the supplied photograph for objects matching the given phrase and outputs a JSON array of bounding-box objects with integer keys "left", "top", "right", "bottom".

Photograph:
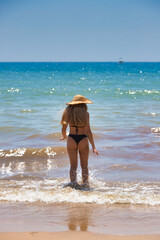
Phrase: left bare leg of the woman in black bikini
[{"left": 67, "top": 137, "right": 78, "bottom": 182}]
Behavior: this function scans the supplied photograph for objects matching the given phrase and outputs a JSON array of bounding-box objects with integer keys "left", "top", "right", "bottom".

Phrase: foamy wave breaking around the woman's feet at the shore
[{"left": 0, "top": 178, "right": 160, "bottom": 206}]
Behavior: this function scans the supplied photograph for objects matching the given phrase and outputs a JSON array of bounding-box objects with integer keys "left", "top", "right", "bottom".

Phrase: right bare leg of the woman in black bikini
[{"left": 78, "top": 137, "right": 89, "bottom": 186}]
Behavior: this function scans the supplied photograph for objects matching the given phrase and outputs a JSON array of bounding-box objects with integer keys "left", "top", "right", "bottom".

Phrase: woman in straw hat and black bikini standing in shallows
[{"left": 60, "top": 95, "right": 98, "bottom": 187}]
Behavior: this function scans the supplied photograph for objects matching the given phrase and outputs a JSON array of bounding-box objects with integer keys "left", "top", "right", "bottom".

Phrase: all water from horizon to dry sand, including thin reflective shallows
[{"left": 0, "top": 62, "right": 160, "bottom": 234}]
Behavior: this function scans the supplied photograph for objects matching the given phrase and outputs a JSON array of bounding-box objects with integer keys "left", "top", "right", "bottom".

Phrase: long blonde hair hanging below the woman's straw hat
[{"left": 61, "top": 103, "right": 87, "bottom": 126}]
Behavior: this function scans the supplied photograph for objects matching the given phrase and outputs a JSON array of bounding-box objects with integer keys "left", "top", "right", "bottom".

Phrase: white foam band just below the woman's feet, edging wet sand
[{"left": 0, "top": 183, "right": 160, "bottom": 206}]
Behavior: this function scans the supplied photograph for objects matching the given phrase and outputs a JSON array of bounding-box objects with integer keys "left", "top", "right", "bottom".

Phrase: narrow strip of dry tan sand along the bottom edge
[{"left": 0, "top": 231, "right": 160, "bottom": 240}]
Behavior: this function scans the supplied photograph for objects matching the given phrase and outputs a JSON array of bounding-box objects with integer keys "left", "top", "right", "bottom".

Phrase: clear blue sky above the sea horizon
[{"left": 0, "top": 0, "right": 160, "bottom": 61}]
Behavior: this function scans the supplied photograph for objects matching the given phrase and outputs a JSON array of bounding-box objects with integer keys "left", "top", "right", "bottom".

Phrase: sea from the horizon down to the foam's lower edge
[{"left": 0, "top": 62, "right": 160, "bottom": 205}]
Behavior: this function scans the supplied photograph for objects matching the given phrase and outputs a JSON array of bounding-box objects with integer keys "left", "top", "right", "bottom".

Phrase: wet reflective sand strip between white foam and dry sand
[{"left": 0, "top": 203, "right": 160, "bottom": 236}]
